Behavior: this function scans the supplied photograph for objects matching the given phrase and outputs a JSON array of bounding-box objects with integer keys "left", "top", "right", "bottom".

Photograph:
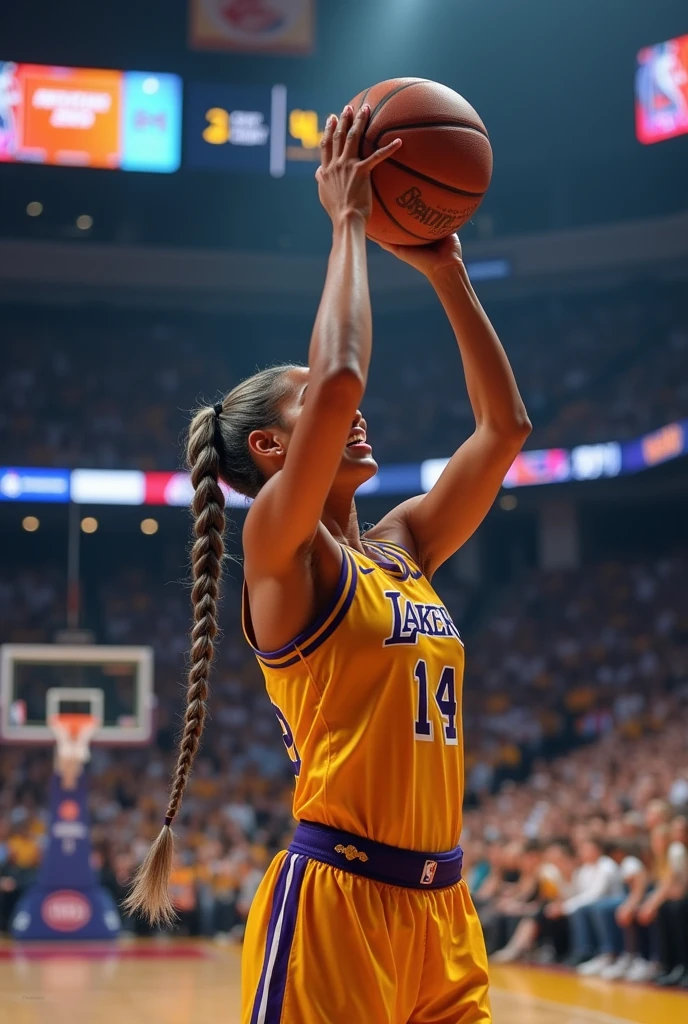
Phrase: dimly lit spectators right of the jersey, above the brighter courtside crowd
[{"left": 464, "top": 553, "right": 688, "bottom": 794}]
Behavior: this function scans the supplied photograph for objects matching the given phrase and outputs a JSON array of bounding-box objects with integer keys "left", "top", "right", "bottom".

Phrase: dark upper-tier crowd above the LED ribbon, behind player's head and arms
[{"left": 0, "top": 285, "right": 688, "bottom": 470}]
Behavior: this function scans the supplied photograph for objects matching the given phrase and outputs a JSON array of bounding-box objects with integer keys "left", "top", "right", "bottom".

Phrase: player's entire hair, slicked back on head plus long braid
[{"left": 123, "top": 365, "right": 296, "bottom": 925}]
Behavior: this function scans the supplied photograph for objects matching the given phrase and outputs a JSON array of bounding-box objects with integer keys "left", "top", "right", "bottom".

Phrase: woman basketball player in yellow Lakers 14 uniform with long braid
[{"left": 124, "top": 106, "right": 529, "bottom": 1024}]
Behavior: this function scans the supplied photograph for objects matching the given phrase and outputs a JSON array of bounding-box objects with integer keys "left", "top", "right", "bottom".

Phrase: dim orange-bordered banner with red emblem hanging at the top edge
[{"left": 189, "top": 0, "right": 315, "bottom": 53}]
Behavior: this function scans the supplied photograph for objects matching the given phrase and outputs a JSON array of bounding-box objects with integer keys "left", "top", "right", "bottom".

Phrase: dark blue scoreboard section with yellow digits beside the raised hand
[{"left": 185, "top": 83, "right": 327, "bottom": 178}]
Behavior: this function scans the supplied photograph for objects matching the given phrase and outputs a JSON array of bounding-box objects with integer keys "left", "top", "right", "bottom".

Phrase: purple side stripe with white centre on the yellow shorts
[{"left": 251, "top": 853, "right": 308, "bottom": 1024}]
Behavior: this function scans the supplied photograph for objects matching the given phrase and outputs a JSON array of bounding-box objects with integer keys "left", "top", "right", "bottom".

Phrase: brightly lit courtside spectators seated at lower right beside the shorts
[{"left": 463, "top": 712, "right": 688, "bottom": 988}]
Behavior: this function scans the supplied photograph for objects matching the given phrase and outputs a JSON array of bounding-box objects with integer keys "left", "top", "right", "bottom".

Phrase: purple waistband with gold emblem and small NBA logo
[{"left": 289, "top": 821, "right": 464, "bottom": 889}]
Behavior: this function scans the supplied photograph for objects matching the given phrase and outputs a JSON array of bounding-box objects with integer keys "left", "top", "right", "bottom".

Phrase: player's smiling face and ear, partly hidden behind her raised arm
[{"left": 249, "top": 367, "right": 378, "bottom": 490}]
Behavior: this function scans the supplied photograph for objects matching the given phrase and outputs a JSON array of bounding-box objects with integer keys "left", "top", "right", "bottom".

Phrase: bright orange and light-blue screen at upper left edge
[{"left": 0, "top": 60, "right": 181, "bottom": 174}]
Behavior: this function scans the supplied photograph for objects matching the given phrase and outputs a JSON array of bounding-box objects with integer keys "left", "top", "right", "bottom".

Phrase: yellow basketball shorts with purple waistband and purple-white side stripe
[{"left": 242, "top": 825, "right": 491, "bottom": 1024}]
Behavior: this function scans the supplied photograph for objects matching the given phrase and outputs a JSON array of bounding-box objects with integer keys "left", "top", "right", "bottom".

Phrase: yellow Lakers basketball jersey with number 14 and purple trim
[{"left": 244, "top": 541, "right": 464, "bottom": 852}]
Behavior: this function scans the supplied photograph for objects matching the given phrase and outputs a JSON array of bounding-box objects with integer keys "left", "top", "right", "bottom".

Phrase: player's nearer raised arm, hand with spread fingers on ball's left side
[{"left": 244, "top": 104, "right": 400, "bottom": 577}]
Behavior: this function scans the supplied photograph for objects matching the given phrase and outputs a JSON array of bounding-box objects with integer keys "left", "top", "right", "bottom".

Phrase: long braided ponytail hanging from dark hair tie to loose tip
[{"left": 123, "top": 404, "right": 224, "bottom": 925}]
